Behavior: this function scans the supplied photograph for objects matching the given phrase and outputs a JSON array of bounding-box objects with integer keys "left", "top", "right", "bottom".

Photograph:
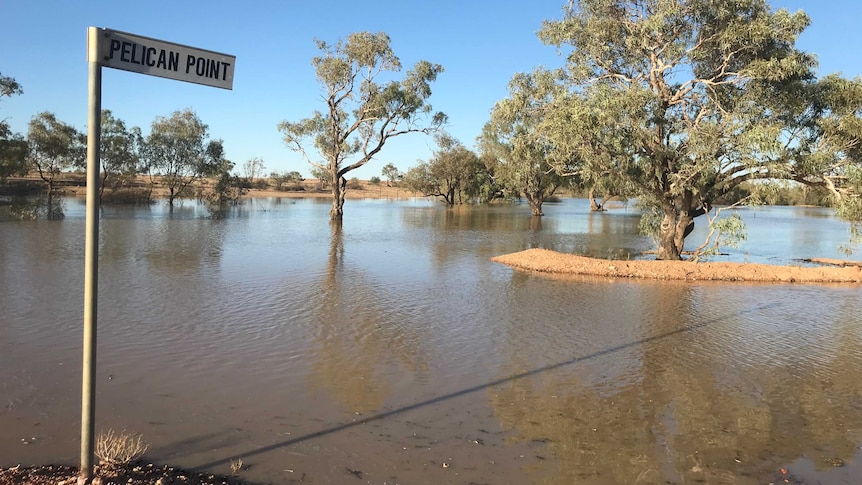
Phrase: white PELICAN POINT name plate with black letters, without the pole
[{"left": 88, "top": 29, "right": 236, "bottom": 89}]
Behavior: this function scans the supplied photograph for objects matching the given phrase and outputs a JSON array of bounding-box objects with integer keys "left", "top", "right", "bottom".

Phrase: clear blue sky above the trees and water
[{"left": 0, "top": 0, "right": 862, "bottom": 179}]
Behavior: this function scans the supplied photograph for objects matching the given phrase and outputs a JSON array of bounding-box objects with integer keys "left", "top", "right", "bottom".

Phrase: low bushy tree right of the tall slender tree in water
[{"left": 401, "top": 133, "right": 486, "bottom": 206}]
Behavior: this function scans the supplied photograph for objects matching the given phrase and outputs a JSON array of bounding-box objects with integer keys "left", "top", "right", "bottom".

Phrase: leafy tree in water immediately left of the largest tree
[{"left": 479, "top": 71, "right": 564, "bottom": 216}]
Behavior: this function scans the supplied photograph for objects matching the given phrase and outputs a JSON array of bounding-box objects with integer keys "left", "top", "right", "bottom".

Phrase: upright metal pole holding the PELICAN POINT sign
[{"left": 79, "top": 27, "right": 102, "bottom": 483}]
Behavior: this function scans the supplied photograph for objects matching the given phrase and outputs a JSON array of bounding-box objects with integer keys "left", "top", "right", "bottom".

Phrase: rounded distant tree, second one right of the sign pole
[{"left": 144, "top": 109, "right": 224, "bottom": 207}]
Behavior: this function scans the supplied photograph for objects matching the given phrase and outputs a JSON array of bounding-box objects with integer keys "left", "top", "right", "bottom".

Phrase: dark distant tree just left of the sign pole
[{"left": 27, "top": 111, "right": 86, "bottom": 195}]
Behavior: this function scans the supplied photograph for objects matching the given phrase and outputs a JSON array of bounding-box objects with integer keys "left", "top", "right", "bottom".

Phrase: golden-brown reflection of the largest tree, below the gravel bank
[{"left": 488, "top": 274, "right": 862, "bottom": 484}]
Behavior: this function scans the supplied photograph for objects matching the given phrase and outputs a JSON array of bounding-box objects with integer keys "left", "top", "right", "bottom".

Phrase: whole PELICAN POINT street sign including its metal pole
[{"left": 78, "top": 27, "right": 236, "bottom": 483}]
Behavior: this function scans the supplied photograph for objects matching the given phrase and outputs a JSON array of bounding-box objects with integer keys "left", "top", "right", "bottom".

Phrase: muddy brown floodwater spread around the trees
[{"left": 0, "top": 199, "right": 862, "bottom": 484}]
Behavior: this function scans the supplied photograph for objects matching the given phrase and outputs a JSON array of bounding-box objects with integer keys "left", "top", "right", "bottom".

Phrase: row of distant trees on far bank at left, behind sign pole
[{"left": 0, "top": 76, "right": 272, "bottom": 212}]
